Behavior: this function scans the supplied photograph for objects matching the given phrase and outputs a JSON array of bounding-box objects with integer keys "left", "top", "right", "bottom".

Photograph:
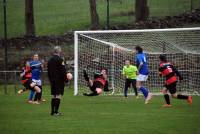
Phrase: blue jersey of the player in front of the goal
[{"left": 136, "top": 53, "right": 149, "bottom": 75}]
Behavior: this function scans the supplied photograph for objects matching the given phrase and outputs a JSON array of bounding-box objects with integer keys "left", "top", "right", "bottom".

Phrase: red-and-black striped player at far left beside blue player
[{"left": 18, "top": 61, "right": 41, "bottom": 97}]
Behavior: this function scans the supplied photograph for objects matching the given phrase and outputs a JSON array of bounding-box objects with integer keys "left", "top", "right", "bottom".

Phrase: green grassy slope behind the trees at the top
[{"left": 0, "top": 0, "right": 200, "bottom": 37}]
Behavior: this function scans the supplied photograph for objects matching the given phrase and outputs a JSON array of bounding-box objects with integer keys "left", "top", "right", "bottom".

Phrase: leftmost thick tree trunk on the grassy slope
[{"left": 25, "top": 0, "right": 35, "bottom": 36}]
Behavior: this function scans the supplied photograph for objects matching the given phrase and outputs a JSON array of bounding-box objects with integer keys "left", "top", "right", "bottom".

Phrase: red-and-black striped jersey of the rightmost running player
[{"left": 159, "top": 62, "right": 180, "bottom": 85}]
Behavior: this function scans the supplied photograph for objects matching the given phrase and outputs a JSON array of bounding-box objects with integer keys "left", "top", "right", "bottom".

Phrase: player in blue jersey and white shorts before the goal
[{"left": 135, "top": 46, "right": 152, "bottom": 104}]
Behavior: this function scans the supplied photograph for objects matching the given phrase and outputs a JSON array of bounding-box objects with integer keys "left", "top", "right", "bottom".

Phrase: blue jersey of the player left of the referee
[{"left": 30, "top": 60, "right": 42, "bottom": 80}]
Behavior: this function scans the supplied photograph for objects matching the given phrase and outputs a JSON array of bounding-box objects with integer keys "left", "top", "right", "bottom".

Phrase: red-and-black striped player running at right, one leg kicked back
[{"left": 159, "top": 55, "right": 192, "bottom": 107}]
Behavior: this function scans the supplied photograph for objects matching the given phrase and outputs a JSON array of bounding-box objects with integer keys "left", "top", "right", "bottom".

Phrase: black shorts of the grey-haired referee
[{"left": 51, "top": 80, "right": 65, "bottom": 95}]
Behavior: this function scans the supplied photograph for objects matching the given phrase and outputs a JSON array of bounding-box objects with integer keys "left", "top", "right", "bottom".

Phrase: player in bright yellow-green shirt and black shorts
[{"left": 122, "top": 60, "right": 138, "bottom": 98}]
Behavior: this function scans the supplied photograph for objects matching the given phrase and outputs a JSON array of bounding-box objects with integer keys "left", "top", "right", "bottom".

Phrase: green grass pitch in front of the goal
[{"left": 0, "top": 88, "right": 200, "bottom": 134}]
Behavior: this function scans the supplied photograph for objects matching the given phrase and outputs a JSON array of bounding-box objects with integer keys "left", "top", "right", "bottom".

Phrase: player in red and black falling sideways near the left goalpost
[{"left": 83, "top": 69, "right": 110, "bottom": 96}]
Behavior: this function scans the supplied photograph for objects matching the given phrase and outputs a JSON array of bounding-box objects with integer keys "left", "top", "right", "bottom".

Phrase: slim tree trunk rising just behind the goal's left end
[{"left": 89, "top": 0, "right": 99, "bottom": 29}]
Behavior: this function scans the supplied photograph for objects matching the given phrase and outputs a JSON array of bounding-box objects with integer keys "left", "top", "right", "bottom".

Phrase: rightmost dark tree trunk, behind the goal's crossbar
[{"left": 135, "top": 0, "right": 149, "bottom": 21}]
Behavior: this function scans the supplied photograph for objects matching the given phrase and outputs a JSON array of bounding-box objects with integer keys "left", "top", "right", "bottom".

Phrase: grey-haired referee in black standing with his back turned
[{"left": 47, "top": 46, "right": 67, "bottom": 116}]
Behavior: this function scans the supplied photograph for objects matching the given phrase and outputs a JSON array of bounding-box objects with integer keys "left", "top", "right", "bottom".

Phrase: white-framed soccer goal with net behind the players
[{"left": 74, "top": 27, "right": 200, "bottom": 95}]
